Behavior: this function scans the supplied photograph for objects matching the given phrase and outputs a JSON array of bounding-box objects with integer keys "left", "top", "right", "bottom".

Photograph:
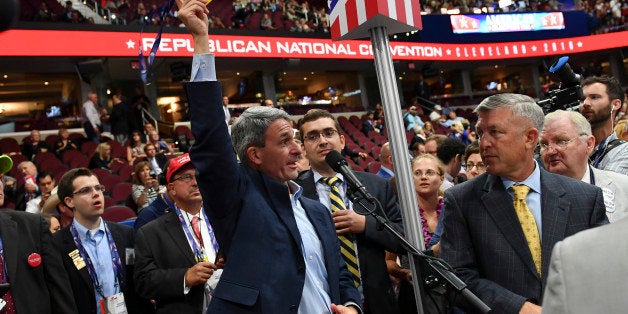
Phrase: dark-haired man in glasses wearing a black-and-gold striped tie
[{"left": 295, "top": 109, "right": 403, "bottom": 313}]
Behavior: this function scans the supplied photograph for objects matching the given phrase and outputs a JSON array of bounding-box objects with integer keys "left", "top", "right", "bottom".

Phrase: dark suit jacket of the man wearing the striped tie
[{"left": 296, "top": 170, "right": 403, "bottom": 314}]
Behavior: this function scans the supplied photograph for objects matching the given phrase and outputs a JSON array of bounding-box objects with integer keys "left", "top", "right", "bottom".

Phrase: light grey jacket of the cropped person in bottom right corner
[{"left": 543, "top": 219, "right": 628, "bottom": 314}]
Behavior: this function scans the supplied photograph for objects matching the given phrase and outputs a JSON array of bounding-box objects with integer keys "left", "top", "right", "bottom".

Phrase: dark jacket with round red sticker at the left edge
[{"left": 0, "top": 211, "right": 79, "bottom": 314}]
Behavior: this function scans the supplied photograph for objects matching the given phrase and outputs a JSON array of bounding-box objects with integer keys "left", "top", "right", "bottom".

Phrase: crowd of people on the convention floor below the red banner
[{"left": 0, "top": 0, "right": 628, "bottom": 314}]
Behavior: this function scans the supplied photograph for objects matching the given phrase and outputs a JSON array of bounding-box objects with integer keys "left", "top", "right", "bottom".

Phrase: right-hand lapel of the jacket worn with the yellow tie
[{"left": 541, "top": 169, "right": 570, "bottom": 278}]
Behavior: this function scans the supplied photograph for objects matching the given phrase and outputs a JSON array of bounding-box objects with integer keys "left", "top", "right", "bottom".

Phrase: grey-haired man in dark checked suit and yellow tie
[{"left": 441, "top": 94, "right": 608, "bottom": 313}]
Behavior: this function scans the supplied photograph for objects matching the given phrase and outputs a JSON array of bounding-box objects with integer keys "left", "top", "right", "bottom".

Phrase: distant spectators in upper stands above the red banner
[{"left": 23, "top": 0, "right": 628, "bottom": 34}]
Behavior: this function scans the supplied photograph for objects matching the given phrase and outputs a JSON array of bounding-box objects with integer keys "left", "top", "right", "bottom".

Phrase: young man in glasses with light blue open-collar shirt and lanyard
[{"left": 53, "top": 168, "right": 148, "bottom": 313}]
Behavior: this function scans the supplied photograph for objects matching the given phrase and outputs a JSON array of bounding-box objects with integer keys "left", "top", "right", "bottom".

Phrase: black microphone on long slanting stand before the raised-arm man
[{"left": 347, "top": 186, "right": 491, "bottom": 313}]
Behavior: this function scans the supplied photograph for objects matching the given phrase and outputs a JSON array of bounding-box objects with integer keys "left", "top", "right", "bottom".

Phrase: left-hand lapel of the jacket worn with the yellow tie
[{"left": 482, "top": 175, "right": 538, "bottom": 276}]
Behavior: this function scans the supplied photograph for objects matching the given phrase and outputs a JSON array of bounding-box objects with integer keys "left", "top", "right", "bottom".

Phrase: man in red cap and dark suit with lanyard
[{"left": 135, "top": 154, "right": 222, "bottom": 313}]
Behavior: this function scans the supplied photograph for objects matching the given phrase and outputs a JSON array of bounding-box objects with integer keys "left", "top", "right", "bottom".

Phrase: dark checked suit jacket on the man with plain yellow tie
[{"left": 440, "top": 169, "right": 608, "bottom": 313}]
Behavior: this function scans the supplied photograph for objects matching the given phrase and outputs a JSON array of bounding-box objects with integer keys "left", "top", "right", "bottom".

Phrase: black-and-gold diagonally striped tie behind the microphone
[{"left": 323, "top": 177, "right": 360, "bottom": 287}]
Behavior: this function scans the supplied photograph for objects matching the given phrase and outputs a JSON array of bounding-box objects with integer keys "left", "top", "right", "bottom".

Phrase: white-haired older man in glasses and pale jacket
[{"left": 539, "top": 110, "right": 628, "bottom": 222}]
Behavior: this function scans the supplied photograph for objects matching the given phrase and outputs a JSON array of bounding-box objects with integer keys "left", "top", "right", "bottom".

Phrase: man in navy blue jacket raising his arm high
[{"left": 177, "top": 0, "right": 361, "bottom": 313}]
